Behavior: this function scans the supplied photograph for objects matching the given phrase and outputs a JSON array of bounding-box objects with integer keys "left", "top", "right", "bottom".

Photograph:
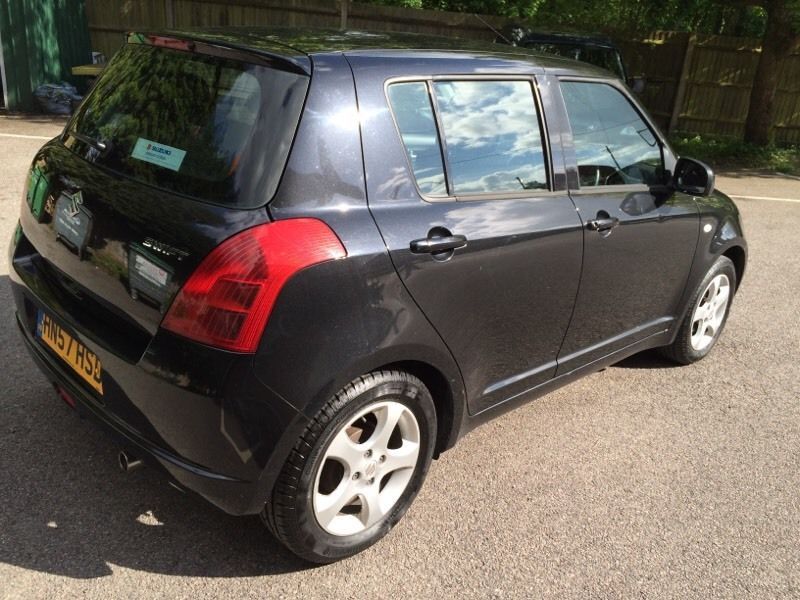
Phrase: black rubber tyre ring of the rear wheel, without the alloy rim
[{"left": 286, "top": 378, "right": 436, "bottom": 562}]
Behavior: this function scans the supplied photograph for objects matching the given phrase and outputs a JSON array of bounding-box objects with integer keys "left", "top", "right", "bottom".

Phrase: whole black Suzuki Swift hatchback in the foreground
[{"left": 10, "top": 30, "right": 746, "bottom": 562}]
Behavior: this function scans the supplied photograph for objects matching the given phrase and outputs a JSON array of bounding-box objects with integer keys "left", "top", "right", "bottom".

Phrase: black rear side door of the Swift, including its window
[{"left": 349, "top": 56, "right": 582, "bottom": 414}]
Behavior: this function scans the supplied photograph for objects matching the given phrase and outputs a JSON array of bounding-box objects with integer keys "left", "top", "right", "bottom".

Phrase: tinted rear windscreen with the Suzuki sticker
[{"left": 65, "top": 44, "right": 308, "bottom": 207}]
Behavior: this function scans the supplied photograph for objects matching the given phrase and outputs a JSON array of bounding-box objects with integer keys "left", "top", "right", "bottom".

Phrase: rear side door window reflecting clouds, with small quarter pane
[{"left": 389, "top": 80, "right": 549, "bottom": 197}]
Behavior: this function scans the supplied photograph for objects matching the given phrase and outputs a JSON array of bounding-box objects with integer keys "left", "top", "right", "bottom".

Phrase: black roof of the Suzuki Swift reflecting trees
[{"left": 161, "top": 27, "right": 613, "bottom": 78}]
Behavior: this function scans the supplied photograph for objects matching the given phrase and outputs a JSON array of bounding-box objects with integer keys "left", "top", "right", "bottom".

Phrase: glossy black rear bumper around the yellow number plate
[{"left": 10, "top": 237, "right": 306, "bottom": 515}]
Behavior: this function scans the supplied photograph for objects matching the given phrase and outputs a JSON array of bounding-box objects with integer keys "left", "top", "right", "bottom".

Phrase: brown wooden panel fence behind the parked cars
[{"left": 86, "top": 0, "right": 800, "bottom": 143}]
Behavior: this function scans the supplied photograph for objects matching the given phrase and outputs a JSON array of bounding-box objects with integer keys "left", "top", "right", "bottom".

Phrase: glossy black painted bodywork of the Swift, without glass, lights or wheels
[{"left": 10, "top": 30, "right": 746, "bottom": 514}]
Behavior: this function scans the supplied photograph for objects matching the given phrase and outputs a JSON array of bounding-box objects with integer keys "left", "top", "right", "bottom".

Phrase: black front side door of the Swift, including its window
[{"left": 558, "top": 79, "right": 699, "bottom": 375}]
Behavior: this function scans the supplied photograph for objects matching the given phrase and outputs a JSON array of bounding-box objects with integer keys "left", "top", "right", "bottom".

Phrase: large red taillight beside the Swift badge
[{"left": 161, "top": 219, "right": 347, "bottom": 352}]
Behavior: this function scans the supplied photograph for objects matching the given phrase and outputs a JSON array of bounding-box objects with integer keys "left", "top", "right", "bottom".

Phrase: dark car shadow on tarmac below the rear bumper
[{"left": 0, "top": 275, "right": 309, "bottom": 578}]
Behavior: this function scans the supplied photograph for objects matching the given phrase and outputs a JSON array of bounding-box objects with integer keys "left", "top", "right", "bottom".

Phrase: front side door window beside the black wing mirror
[{"left": 561, "top": 81, "right": 663, "bottom": 187}]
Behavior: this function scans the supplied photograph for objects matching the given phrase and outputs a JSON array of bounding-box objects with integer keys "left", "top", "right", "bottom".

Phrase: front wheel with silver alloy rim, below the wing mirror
[{"left": 661, "top": 256, "right": 736, "bottom": 365}]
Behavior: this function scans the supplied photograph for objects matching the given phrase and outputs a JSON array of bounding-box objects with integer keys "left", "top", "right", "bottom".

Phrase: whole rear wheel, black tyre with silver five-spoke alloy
[{"left": 261, "top": 371, "right": 436, "bottom": 564}]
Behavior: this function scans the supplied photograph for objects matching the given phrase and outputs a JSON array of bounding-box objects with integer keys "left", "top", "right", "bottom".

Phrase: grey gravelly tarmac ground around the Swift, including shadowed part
[{"left": 0, "top": 118, "right": 800, "bottom": 600}]
